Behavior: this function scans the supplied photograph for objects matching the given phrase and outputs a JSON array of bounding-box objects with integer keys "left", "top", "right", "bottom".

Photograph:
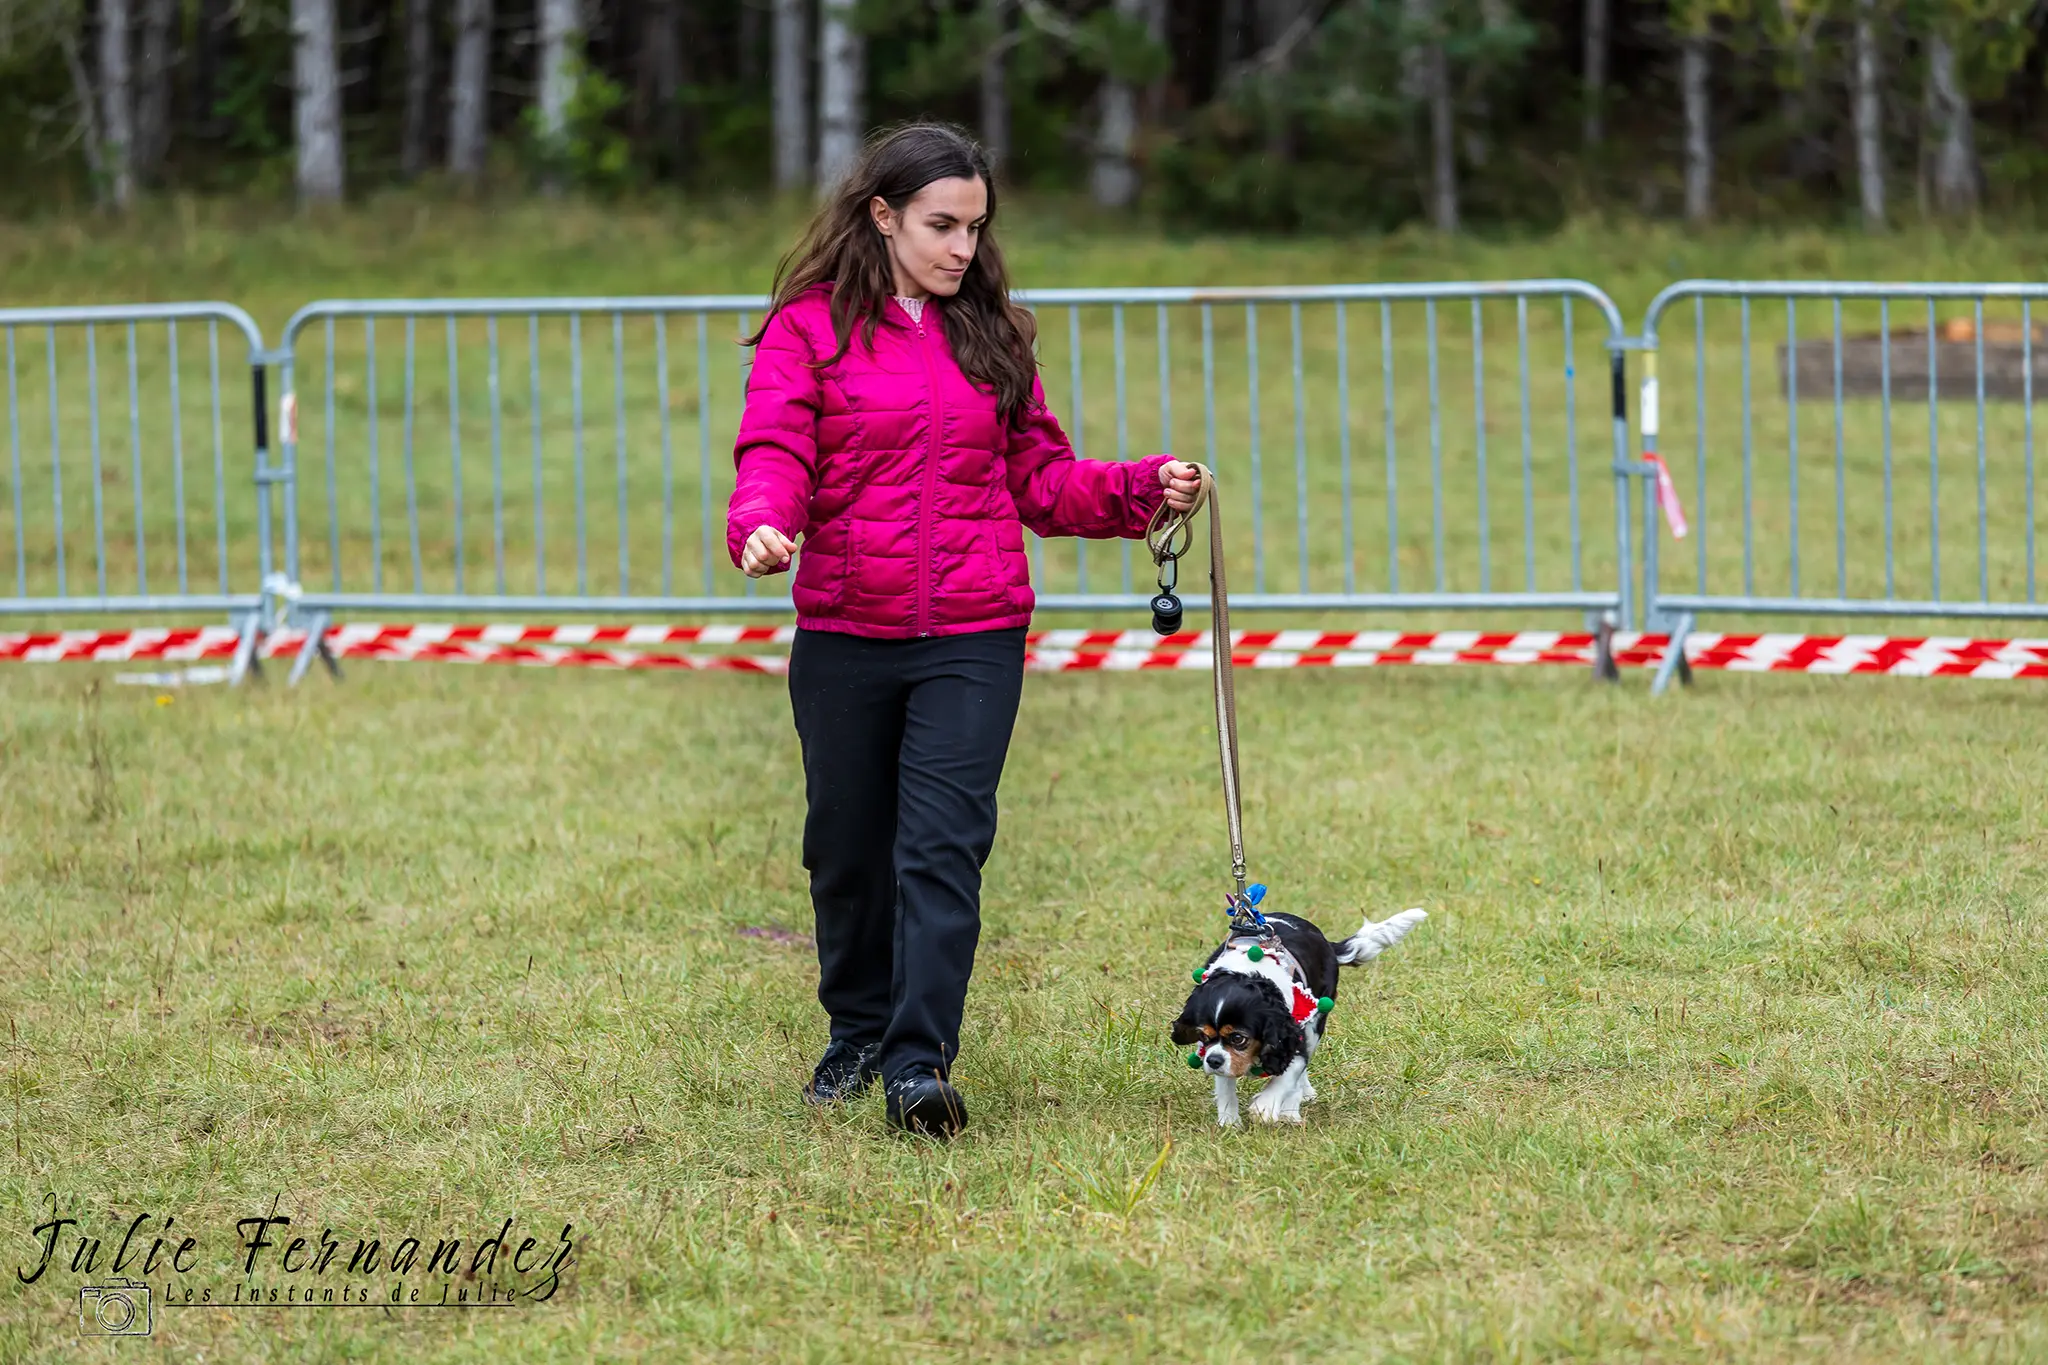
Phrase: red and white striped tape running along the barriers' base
[{"left": 0, "top": 624, "right": 2048, "bottom": 679}]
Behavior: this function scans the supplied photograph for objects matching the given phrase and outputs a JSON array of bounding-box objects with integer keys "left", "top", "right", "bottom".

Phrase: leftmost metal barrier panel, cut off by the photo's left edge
[{"left": 0, "top": 303, "right": 272, "bottom": 616}]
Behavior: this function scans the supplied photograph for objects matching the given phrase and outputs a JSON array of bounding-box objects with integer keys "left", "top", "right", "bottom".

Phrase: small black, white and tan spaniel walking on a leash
[{"left": 1174, "top": 908, "right": 1427, "bottom": 1126}]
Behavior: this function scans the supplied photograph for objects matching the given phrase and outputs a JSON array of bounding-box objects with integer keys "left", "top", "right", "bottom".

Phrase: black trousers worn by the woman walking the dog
[{"left": 788, "top": 628, "right": 1024, "bottom": 1083}]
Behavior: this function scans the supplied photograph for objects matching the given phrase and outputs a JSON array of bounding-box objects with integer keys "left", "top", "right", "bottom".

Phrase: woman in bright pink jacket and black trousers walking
[{"left": 727, "top": 123, "right": 1198, "bottom": 1136}]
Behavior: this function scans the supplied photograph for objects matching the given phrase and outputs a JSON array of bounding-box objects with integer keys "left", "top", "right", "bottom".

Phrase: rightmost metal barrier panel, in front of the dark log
[{"left": 1638, "top": 280, "right": 2048, "bottom": 692}]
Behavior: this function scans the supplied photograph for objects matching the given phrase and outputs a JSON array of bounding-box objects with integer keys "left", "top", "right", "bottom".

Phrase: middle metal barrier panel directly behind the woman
[{"left": 279, "top": 280, "right": 1632, "bottom": 646}]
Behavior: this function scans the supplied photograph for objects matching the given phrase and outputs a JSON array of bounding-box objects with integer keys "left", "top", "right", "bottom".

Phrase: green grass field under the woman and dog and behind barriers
[{"left": 0, "top": 203, "right": 2048, "bottom": 1363}]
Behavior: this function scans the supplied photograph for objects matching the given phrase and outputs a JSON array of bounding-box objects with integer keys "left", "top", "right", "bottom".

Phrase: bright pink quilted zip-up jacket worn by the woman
[{"left": 725, "top": 284, "right": 1171, "bottom": 639}]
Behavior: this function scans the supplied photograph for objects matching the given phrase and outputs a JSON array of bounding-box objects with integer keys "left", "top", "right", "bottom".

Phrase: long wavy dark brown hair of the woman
[{"left": 745, "top": 123, "right": 1038, "bottom": 426}]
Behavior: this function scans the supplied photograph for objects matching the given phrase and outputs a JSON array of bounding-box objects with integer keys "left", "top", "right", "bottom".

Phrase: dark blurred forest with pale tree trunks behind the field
[{"left": 0, "top": 0, "right": 2048, "bottom": 231}]
